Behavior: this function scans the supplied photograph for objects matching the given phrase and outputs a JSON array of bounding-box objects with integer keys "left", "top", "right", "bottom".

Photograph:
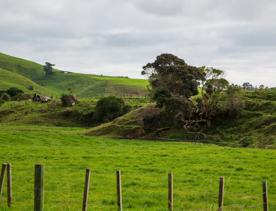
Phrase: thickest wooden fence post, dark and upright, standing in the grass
[{"left": 34, "top": 165, "right": 44, "bottom": 211}]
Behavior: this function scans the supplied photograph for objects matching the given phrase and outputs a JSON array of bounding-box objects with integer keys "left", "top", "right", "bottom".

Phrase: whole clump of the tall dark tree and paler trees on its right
[{"left": 142, "top": 54, "right": 241, "bottom": 127}]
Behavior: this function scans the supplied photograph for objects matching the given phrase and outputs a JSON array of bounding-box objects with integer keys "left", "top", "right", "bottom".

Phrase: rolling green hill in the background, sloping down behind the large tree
[{"left": 0, "top": 53, "right": 148, "bottom": 97}]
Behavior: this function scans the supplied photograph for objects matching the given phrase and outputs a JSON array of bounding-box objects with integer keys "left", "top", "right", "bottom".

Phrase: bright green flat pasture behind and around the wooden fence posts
[{"left": 0, "top": 124, "right": 276, "bottom": 211}]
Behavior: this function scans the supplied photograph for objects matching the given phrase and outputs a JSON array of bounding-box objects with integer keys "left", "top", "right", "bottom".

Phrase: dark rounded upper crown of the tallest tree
[{"left": 142, "top": 54, "right": 204, "bottom": 98}]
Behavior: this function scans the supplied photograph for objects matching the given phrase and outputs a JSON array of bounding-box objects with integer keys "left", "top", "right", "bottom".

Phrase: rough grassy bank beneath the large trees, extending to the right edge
[{"left": 87, "top": 89, "right": 276, "bottom": 148}]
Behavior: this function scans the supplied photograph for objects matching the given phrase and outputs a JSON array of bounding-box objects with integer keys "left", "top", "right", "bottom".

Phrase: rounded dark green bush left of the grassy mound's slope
[{"left": 93, "top": 96, "right": 130, "bottom": 123}]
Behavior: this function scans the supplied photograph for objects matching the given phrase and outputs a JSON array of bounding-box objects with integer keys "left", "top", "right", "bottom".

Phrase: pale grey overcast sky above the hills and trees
[{"left": 0, "top": 0, "right": 276, "bottom": 86}]
